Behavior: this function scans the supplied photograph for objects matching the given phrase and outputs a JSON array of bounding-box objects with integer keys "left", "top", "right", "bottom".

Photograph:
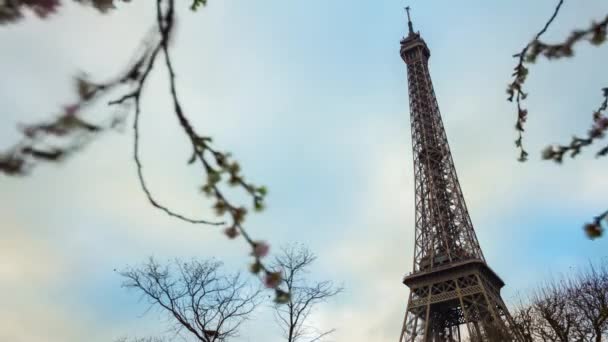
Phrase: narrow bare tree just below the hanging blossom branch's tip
[{"left": 273, "top": 245, "right": 343, "bottom": 342}]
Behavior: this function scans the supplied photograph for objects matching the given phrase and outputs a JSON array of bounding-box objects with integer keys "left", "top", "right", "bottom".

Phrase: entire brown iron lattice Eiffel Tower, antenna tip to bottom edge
[{"left": 399, "top": 8, "right": 522, "bottom": 342}]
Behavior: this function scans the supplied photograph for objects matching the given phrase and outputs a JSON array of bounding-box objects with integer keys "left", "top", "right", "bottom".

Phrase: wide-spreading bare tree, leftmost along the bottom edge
[{"left": 120, "top": 258, "right": 261, "bottom": 342}]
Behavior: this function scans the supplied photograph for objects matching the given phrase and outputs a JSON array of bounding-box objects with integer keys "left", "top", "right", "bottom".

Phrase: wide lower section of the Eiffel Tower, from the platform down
[{"left": 399, "top": 260, "right": 523, "bottom": 342}]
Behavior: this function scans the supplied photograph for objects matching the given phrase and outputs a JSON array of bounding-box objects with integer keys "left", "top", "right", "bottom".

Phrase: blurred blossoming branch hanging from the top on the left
[{"left": 0, "top": 0, "right": 288, "bottom": 296}]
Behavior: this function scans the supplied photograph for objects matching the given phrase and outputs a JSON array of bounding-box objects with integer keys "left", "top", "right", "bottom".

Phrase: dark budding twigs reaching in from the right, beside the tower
[{"left": 507, "top": 0, "right": 608, "bottom": 239}]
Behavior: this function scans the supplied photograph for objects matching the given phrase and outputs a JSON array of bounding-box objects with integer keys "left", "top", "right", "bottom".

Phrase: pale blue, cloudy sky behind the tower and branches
[{"left": 0, "top": 0, "right": 608, "bottom": 342}]
